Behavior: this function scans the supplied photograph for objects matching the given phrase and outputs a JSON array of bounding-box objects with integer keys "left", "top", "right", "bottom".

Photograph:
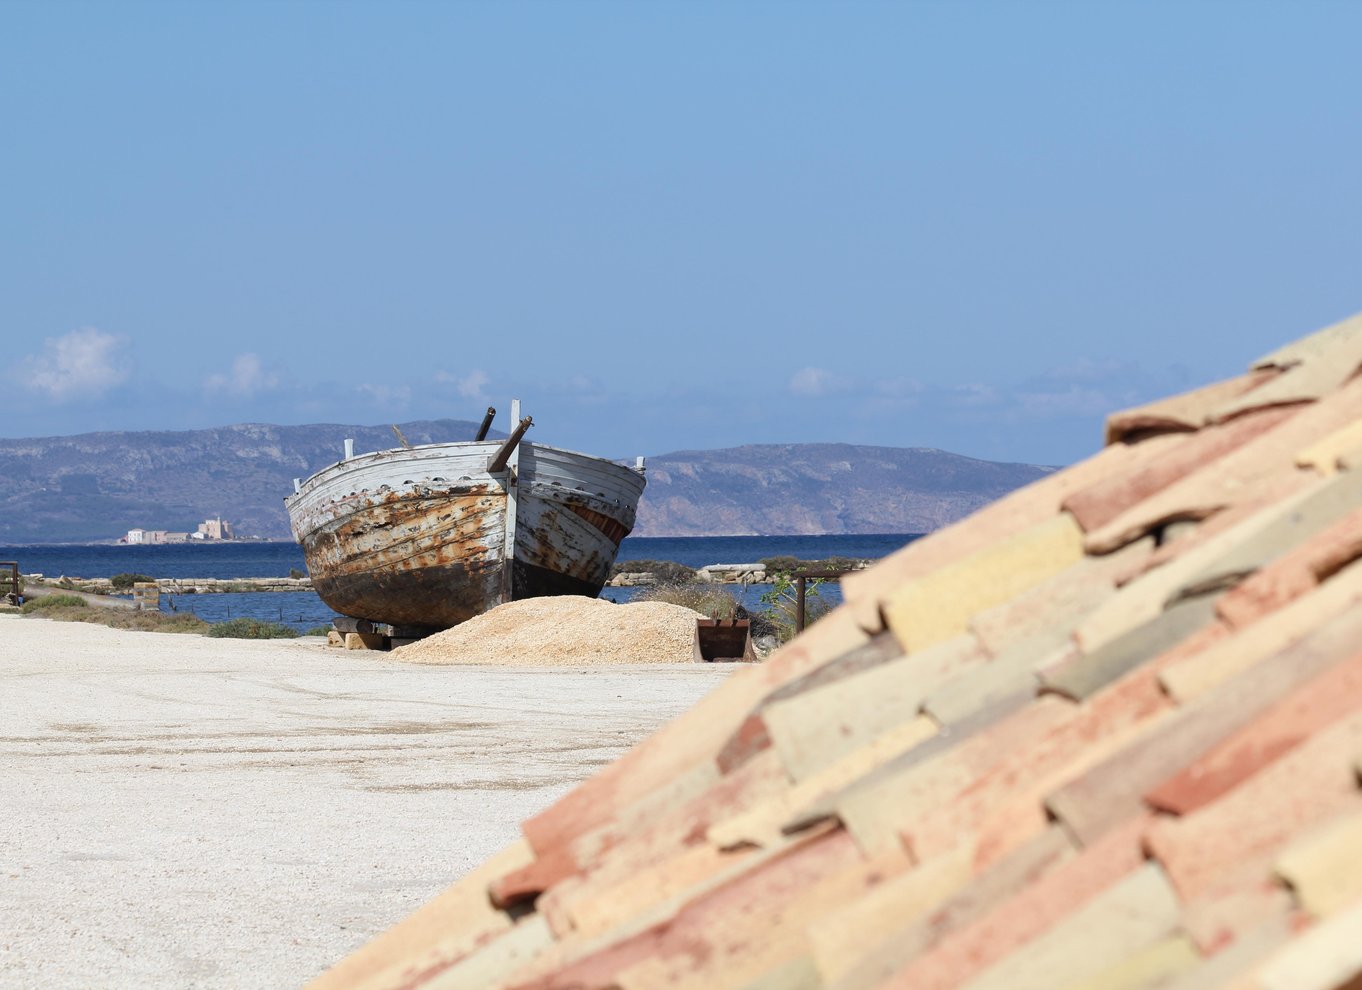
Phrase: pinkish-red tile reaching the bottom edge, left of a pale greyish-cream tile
[{"left": 881, "top": 817, "right": 1148, "bottom": 990}]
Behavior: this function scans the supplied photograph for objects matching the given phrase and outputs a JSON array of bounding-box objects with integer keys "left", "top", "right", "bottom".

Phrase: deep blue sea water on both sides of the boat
[{"left": 0, "top": 534, "right": 919, "bottom": 630}]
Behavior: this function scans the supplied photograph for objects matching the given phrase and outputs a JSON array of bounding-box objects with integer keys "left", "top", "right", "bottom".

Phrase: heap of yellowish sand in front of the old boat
[{"left": 388, "top": 595, "right": 704, "bottom": 667}]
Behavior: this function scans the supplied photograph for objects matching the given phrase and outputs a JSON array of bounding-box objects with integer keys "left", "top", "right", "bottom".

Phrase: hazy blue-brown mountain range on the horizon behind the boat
[{"left": 0, "top": 419, "right": 1053, "bottom": 543}]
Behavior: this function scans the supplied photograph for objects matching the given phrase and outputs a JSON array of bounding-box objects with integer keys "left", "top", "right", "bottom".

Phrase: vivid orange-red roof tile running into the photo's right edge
[{"left": 1144, "top": 644, "right": 1362, "bottom": 814}]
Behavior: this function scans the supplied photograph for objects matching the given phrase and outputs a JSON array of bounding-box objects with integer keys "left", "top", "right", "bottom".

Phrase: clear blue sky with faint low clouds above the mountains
[{"left": 0, "top": 0, "right": 1362, "bottom": 463}]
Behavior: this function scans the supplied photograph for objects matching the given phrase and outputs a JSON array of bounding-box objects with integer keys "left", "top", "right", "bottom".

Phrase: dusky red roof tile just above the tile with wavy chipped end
[{"left": 1064, "top": 406, "right": 1299, "bottom": 532}]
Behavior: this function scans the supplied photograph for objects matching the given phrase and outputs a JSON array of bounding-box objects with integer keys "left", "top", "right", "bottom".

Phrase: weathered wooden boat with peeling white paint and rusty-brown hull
[{"left": 285, "top": 403, "right": 644, "bottom": 629}]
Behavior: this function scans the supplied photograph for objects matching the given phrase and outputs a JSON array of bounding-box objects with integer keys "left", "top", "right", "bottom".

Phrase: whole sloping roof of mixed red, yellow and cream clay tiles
[{"left": 315, "top": 316, "right": 1362, "bottom": 990}]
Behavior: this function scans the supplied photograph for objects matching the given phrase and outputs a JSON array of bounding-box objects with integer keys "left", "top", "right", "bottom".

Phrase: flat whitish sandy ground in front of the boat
[{"left": 0, "top": 614, "right": 731, "bottom": 989}]
